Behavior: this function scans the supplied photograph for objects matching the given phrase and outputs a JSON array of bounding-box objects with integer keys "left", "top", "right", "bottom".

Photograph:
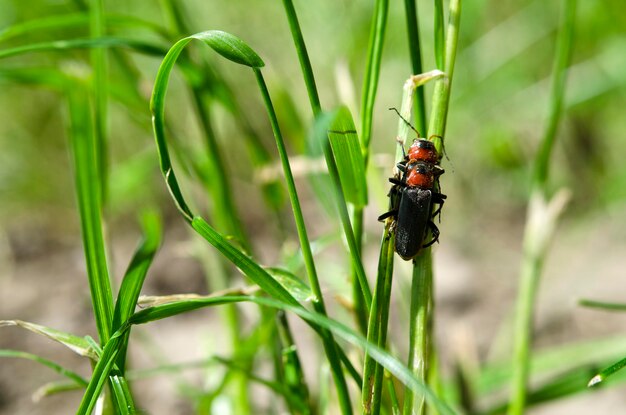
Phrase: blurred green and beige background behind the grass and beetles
[{"left": 0, "top": 0, "right": 626, "bottom": 414}]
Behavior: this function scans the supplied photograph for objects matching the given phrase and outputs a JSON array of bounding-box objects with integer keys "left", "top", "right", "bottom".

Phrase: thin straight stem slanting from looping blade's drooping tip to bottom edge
[{"left": 253, "top": 68, "right": 352, "bottom": 415}]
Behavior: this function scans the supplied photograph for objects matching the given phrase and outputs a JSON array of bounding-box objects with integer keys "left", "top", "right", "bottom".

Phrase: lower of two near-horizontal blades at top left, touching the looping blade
[{"left": 0, "top": 37, "right": 166, "bottom": 59}]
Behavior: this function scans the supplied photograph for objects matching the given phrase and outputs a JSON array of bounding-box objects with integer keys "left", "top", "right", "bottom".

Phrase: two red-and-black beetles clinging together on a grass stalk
[{"left": 378, "top": 127, "right": 446, "bottom": 261}]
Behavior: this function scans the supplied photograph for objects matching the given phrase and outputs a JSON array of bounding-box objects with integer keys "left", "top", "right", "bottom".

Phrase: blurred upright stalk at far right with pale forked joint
[{"left": 508, "top": 0, "right": 576, "bottom": 415}]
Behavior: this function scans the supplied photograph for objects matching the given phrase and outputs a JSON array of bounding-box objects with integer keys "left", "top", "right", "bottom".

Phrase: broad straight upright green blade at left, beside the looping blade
[{"left": 68, "top": 85, "right": 113, "bottom": 344}]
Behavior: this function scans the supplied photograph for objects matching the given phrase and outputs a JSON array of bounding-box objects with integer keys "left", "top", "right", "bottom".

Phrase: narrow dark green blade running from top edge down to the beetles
[{"left": 404, "top": 0, "right": 426, "bottom": 133}]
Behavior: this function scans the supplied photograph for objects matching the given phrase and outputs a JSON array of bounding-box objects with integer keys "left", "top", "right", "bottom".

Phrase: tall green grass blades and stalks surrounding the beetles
[{"left": 0, "top": 0, "right": 626, "bottom": 415}]
